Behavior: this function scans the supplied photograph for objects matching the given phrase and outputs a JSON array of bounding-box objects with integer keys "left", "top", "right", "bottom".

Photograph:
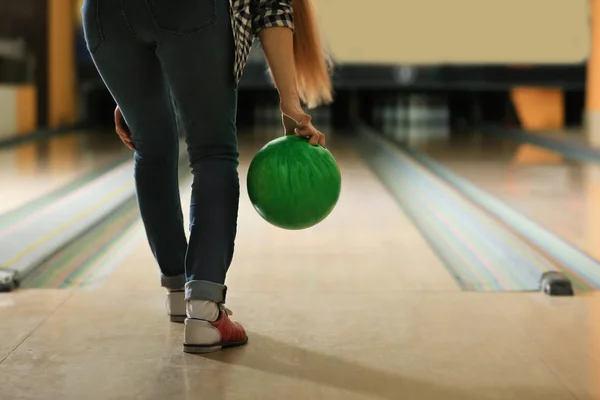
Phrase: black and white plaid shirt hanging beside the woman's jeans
[{"left": 229, "top": 0, "right": 294, "bottom": 83}]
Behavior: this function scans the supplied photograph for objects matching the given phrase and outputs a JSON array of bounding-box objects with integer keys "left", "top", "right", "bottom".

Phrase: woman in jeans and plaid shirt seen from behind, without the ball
[{"left": 82, "top": 0, "right": 332, "bottom": 353}]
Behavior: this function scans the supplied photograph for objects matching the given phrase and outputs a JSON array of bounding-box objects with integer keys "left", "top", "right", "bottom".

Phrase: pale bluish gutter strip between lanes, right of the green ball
[{"left": 359, "top": 126, "right": 580, "bottom": 291}]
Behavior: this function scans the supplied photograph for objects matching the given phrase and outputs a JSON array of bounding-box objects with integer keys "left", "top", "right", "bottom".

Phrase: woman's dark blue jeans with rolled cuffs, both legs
[{"left": 82, "top": 0, "right": 240, "bottom": 303}]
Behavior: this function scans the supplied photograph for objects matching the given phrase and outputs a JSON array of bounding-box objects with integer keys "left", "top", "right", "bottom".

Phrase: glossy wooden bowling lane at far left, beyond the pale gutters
[{"left": 0, "top": 132, "right": 127, "bottom": 214}]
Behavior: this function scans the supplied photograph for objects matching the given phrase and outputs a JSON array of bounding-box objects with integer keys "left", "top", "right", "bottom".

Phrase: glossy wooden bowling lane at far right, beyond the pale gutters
[{"left": 413, "top": 133, "right": 600, "bottom": 258}]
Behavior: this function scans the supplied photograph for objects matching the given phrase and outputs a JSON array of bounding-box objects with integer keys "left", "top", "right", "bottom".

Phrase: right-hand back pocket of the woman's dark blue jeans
[{"left": 146, "top": 0, "right": 217, "bottom": 34}]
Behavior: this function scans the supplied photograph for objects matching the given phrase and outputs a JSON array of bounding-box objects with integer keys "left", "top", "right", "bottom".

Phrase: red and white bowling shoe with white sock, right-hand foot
[{"left": 183, "top": 300, "right": 248, "bottom": 354}]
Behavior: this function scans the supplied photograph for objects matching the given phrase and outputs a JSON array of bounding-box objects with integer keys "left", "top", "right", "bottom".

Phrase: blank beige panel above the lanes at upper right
[{"left": 316, "top": 0, "right": 590, "bottom": 64}]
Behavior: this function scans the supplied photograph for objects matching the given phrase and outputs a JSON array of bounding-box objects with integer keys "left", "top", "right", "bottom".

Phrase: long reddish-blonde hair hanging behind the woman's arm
[{"left": 292, "top": 0, "right": 333, "bottom": 108}]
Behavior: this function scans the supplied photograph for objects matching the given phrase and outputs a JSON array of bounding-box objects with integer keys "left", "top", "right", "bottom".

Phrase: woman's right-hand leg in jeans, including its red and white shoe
[{"left": 150, "top": 0, "right": 248, "bottom": 353}]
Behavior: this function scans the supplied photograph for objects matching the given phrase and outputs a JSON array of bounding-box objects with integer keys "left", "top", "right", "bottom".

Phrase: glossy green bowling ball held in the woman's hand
[{"left": 247, "top": 136, "right": 342, "bottom": 230}]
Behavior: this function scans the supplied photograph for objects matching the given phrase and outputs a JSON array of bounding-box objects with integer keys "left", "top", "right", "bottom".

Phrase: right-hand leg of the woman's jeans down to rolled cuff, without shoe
[{"left": 157, "top": 0, "right": 240, "bottom": 303}]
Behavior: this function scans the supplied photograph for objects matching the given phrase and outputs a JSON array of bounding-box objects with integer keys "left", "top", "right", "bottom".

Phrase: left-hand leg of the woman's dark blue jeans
[{"left": 82, "top": 0, "right": 187, "bottom": 289}]
